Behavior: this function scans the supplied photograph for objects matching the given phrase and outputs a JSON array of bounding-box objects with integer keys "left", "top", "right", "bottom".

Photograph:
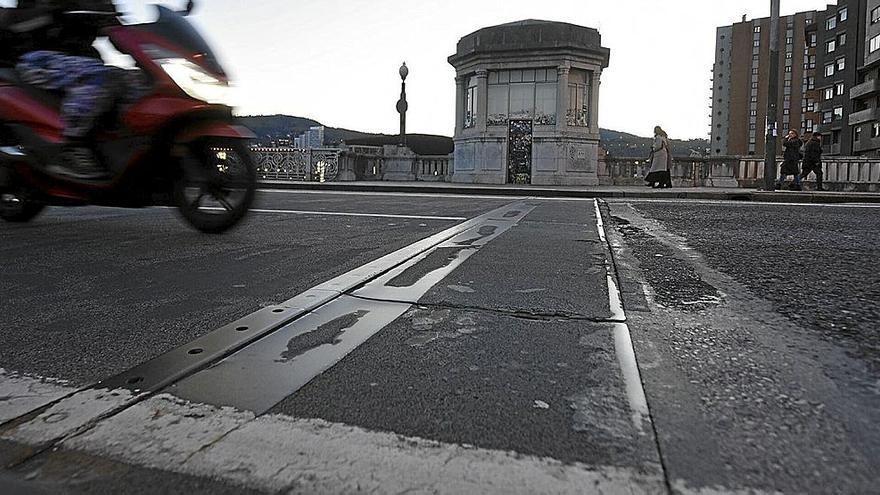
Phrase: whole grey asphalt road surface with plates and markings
[{"left": 0, "top": 191, "right": 880, "bottom": 493}]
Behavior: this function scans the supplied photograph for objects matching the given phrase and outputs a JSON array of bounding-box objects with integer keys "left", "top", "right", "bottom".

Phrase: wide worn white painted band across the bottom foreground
[{"left": 63, "top": 394, "right": 665, "bottom": 494}]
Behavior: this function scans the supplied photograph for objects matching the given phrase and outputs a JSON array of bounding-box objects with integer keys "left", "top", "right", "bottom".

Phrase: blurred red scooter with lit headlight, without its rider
[{"left": 0, "top": 3, "right": 256, "bottom": 233}]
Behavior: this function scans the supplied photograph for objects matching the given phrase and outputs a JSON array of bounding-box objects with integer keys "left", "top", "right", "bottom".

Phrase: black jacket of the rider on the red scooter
[{"left": 0, "top": 0, "right": 116, "bottom": 59}]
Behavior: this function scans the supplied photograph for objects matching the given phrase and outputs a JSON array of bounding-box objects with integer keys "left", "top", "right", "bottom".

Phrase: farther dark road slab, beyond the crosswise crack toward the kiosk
[{"left": 420, "top": 203, "right": 611, "bottom": 319}]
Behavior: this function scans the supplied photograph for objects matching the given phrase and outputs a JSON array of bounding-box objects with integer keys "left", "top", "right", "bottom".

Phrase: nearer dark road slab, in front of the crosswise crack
[{"left": 273, "top": 307, "right": 657, "bottom": 467}]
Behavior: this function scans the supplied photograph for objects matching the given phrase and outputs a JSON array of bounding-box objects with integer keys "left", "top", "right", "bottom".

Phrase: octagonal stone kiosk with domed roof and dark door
[{"left": 449, "top": 20, "right": 610, "bottom": 185}]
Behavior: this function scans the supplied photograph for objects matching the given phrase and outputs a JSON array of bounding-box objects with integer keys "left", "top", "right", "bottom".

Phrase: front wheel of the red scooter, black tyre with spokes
[{"left": 174, "top": 139, "right": 257, "bottom": 234}]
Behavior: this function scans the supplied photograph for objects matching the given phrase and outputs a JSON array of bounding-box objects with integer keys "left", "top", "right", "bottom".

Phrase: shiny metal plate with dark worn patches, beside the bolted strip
[{"left": 168, "top": 203, "right": 534, "bottom": 414}]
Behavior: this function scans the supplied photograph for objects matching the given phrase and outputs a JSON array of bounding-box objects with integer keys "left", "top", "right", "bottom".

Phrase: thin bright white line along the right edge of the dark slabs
[{"left": 594, "top": 200, "right": 651, "bottom": 432}]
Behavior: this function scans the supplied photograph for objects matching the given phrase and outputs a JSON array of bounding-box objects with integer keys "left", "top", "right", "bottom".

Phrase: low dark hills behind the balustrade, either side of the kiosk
[{"left": 241, "top": 115, "right": 709, "bottom": 158}]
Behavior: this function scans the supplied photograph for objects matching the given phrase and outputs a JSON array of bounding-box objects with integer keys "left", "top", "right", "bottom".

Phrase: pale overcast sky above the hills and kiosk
[{"left": 0, "top": 0, "right": 833, "bottom": 139}]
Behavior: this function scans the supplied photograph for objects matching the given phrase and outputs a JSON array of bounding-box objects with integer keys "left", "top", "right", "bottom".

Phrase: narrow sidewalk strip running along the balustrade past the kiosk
[{"left": 259, "top": 181, "right": 880, "bottom": 204}]
